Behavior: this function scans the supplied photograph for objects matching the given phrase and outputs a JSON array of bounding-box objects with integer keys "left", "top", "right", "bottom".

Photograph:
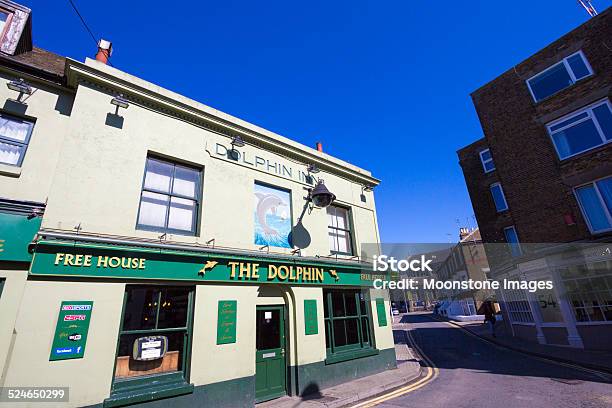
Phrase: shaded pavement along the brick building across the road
[{"left": 434, "top": 316, "right": 612, "bottom": 374}]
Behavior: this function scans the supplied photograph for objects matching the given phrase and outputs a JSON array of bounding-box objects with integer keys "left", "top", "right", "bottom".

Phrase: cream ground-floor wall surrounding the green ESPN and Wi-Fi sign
[{"left": 4, "top": 281, "right": 125, "bottom": 407}]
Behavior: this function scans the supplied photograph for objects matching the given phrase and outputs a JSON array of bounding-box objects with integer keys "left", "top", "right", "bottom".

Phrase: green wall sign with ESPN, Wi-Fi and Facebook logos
[{"left": 49, "top": 301, "right": 93, "bottom": 361}]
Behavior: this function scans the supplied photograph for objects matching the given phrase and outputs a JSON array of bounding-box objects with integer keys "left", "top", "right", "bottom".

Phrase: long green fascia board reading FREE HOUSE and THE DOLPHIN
[{"left": 30, "top": 241, "right": 374, "bottom": 287}]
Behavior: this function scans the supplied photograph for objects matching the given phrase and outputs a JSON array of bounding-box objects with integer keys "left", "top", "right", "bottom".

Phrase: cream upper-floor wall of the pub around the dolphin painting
[{"left": 43, "top": 80, "right": 378, "bottom": 256}]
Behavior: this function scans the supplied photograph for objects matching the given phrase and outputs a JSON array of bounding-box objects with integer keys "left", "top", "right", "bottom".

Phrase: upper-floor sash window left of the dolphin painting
[{"left": 137, "top": 157, "right": 202, "bottom": 235}]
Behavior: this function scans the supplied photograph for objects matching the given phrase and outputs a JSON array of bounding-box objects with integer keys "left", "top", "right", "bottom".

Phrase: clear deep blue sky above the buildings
[{"left": 22, "top": 0, "right": 612, "bottom": 242}]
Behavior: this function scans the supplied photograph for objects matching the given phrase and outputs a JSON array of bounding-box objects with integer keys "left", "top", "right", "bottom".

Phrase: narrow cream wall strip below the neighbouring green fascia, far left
[{"left": 0, "top": 268, "right": 28, "bottom": 387}]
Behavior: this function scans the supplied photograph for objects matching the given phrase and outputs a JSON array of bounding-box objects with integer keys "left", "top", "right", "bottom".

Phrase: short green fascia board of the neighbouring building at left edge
[{"left": 0, "top": 212, "right": 42, "bottom": 262}]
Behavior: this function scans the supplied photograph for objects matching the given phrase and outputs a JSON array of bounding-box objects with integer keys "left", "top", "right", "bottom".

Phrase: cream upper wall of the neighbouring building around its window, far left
[{"left": 0, "top": 73, "right": 73, "bottom": 203}]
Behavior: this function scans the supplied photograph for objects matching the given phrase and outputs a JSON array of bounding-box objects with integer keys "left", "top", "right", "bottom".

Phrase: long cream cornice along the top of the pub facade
[{"left": 65, "top": 58, "right": 380, "bottom": 185}]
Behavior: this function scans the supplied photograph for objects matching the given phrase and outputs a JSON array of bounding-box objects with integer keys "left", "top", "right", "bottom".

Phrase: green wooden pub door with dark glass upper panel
[{"left": 255, "top": 306, "right": 287, "bottom": 402}]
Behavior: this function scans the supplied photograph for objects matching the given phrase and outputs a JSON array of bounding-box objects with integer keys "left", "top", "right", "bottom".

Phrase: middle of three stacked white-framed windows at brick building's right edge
[{"left": 546, "top": 99, "right": 612, "bottom": 160}]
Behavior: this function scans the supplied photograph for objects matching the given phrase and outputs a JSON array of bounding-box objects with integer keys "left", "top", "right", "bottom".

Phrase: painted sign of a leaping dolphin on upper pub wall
[{"left": 254, "top": 183, "right": 291, "bottom": 248}]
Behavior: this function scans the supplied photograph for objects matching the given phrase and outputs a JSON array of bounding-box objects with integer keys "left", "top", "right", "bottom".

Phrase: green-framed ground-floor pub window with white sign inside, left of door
[{"left": 104, "top": 285, "right": 195, "bottom": 407}]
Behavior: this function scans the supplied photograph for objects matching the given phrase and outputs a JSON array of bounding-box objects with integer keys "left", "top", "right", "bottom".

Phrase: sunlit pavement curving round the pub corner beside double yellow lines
[{"left": 257, "top": 317, "right": 421, "bottom": 408}]
